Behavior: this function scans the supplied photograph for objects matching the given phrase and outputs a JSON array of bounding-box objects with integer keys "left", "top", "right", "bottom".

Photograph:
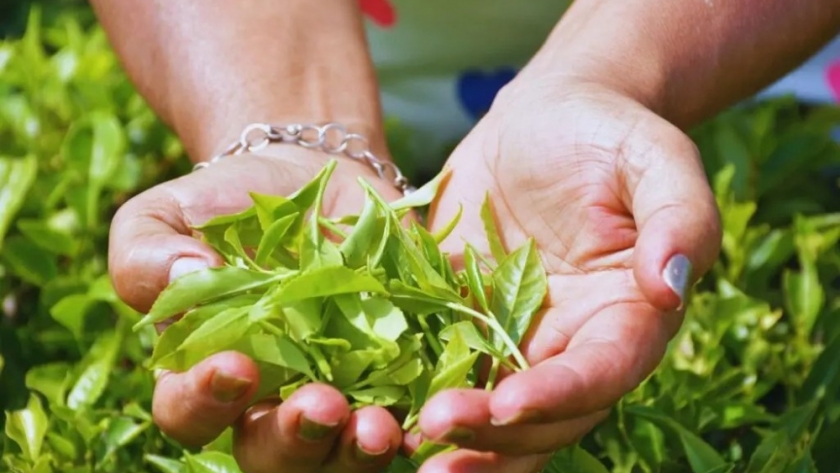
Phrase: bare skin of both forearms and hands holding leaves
[{"left": 93, "top": 0, "right": 840, "bottom": 473}]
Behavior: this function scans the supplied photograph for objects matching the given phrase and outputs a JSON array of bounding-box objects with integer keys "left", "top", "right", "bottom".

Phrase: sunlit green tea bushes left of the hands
[{"left": 0, "top": 10, "right": 188, "bottom": 472}]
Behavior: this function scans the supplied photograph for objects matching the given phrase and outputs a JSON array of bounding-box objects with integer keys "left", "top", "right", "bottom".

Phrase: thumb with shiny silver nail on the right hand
[{"left": 627, "top": 129, "right": 721, "bottom": 310}]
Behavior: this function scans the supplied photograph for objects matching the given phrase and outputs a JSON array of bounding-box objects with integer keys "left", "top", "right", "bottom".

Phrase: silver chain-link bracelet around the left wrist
[{"left": 193, "top": 123, "right": 414, "bottom": 195}]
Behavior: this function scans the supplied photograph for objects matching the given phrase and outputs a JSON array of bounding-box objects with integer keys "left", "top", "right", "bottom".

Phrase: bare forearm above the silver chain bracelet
[{"left": 108, "top": 0, "right": 384, "bottom": 162}]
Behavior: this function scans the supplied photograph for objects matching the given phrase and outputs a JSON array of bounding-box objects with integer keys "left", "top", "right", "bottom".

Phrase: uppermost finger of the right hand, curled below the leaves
[{"left": 490, "top": 300, "right": 672, "bottom": 425}]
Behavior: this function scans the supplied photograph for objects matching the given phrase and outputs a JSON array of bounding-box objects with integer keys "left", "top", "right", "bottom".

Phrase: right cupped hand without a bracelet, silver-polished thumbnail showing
[{"left": 419, "top": 81, "right": 720, "bottom": 473}]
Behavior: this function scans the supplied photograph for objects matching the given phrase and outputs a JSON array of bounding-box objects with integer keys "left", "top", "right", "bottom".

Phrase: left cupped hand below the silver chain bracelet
[{"left": 109, "top": 145, "right": 402, "bottom": 473}]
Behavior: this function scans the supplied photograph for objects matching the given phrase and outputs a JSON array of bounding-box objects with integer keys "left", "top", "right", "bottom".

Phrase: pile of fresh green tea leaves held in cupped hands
[{"left": 135, "top": 160, "right": 547, "bottom": 460}]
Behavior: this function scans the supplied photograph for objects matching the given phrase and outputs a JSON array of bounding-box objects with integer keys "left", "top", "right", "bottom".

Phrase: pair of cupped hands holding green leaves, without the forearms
[{"left": 110, "top": 78, "right": 720, "bottom": 473}]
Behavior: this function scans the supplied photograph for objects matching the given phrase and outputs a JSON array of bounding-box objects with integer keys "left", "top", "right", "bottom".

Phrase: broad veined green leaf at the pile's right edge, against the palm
[{"left": 490, "top": 240, "right": 548, "bottom": 347}]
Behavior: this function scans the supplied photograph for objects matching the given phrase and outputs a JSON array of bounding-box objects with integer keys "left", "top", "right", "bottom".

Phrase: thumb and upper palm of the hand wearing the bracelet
[{"left": 109, "top": 151, "right": 399, "bottom": 312}]
